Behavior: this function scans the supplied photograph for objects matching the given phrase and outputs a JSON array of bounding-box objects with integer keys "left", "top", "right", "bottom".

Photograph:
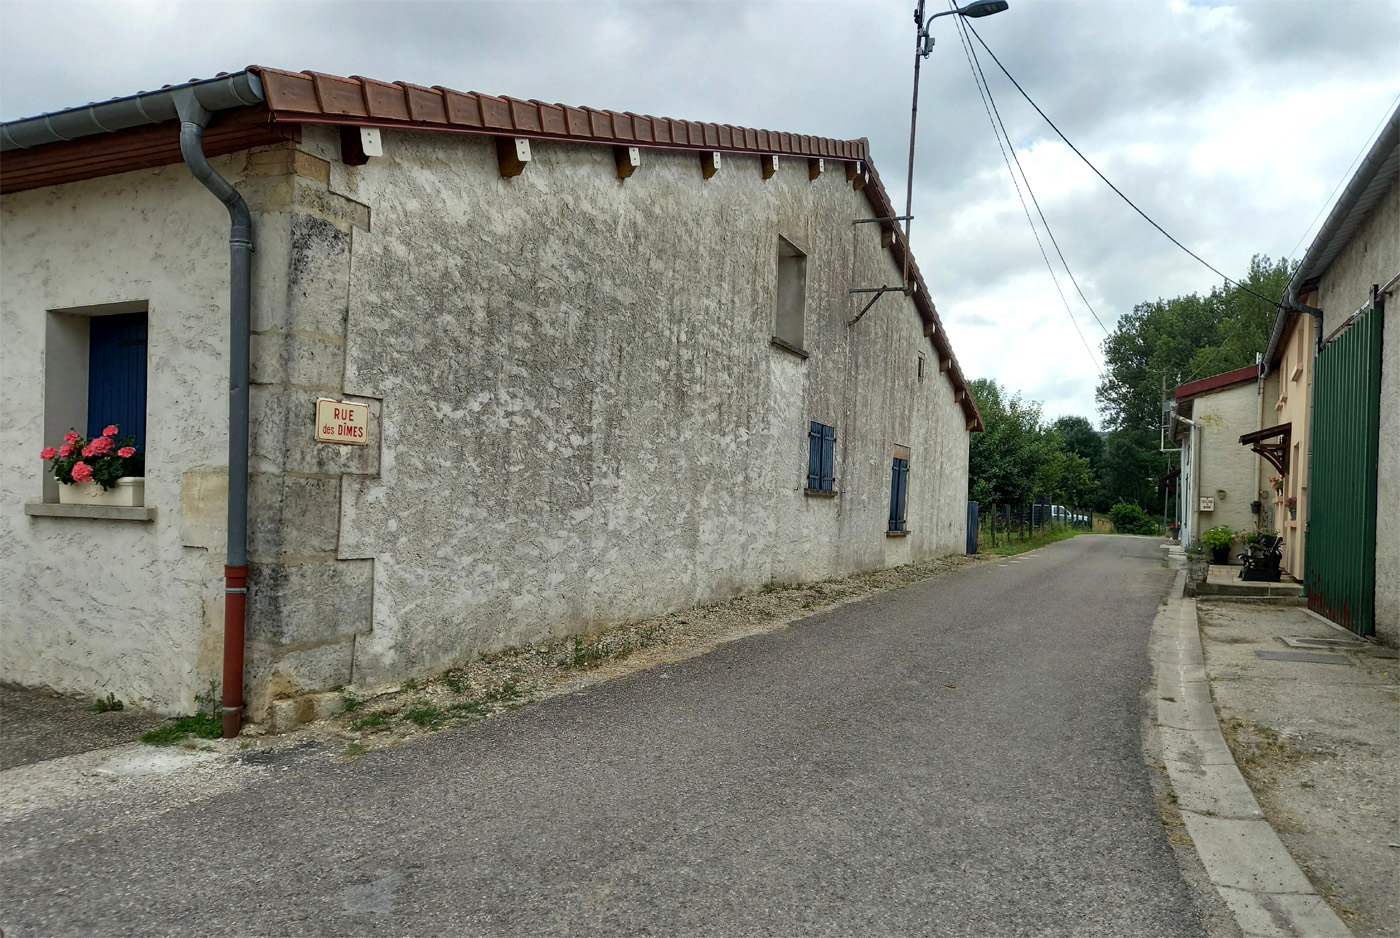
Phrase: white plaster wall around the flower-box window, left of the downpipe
[{"left": 0, "top": 158, "right": 242, "bottom": 713}]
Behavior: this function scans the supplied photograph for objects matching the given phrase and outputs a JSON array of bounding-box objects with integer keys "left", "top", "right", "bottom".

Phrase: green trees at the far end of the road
[{"left": 967, "top": 255, "right": 1296, "bottom": 515}]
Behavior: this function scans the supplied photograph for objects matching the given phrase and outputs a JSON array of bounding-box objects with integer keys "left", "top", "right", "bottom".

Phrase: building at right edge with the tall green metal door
[{"left": 1265, "top": 109, "right": 1400, "bottom": 645}]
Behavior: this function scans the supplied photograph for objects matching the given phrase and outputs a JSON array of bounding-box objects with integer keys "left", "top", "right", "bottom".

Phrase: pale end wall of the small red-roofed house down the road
[{"left": 1190, "top": 381, "right": 1264, "bottom": 556}]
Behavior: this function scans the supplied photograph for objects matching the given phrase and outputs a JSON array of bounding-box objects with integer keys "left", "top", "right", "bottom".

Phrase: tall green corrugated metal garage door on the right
[{"left": 1303, "top": 307, "right": 1385, "bottom": 636}]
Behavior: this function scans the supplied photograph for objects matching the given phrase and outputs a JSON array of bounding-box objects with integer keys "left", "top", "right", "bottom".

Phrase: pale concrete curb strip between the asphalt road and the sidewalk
[{"left": 1152, "top": 571, "right": 1351, "bottom": 938}]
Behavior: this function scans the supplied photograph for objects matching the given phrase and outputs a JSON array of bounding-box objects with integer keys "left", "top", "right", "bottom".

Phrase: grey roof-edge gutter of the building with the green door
[{"left": 1264, "top": 100, "right": 1400, "bottom": 377}]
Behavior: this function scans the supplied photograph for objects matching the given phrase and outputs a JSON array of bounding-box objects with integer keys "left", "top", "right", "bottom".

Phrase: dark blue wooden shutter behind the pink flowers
[{"left": 87, "top": 312, "right": 146, "bottom": 452}]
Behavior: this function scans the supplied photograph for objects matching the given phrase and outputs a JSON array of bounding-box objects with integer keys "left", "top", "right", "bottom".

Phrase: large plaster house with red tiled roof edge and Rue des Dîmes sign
[{"left": 0, "top": 67, "right": 981, "bottom": 732}]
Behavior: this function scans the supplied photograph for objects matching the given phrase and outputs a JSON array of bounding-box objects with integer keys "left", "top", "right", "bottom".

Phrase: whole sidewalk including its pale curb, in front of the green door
[{"left": 1155, "top": 552, "right": 1400, "bottom": 938}]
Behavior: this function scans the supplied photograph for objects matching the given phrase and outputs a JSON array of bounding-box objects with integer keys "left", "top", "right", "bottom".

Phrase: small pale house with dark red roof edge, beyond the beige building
[{"left": 1170, "top": 365, "right": 1261, "bottom": 556}]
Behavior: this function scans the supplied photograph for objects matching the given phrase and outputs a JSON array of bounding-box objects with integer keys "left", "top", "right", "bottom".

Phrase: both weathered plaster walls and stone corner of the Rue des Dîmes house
[{"left": 0, "top": 127, "right": 967, "bottom": 720}]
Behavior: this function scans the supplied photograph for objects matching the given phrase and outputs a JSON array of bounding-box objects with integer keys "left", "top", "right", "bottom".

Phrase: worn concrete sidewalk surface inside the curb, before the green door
[{"left": 1197, "top": 598, "right": 1400, "bottom": 937}]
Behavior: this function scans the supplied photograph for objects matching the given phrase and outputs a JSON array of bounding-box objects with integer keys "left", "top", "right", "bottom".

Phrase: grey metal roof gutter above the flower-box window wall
[{"left": 0, "top": 70, "right": 265, "bottom": 153}]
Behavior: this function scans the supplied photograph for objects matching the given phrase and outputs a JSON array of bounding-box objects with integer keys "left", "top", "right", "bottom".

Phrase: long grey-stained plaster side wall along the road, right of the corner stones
[{"left": 320, "top": 133, "right": 969, "bottom": 683}]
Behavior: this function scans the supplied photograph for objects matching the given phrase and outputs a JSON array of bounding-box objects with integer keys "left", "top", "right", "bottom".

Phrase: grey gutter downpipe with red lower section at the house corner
[{"left": 175, "top": 91, "right": 253, "bottom": 739}]
